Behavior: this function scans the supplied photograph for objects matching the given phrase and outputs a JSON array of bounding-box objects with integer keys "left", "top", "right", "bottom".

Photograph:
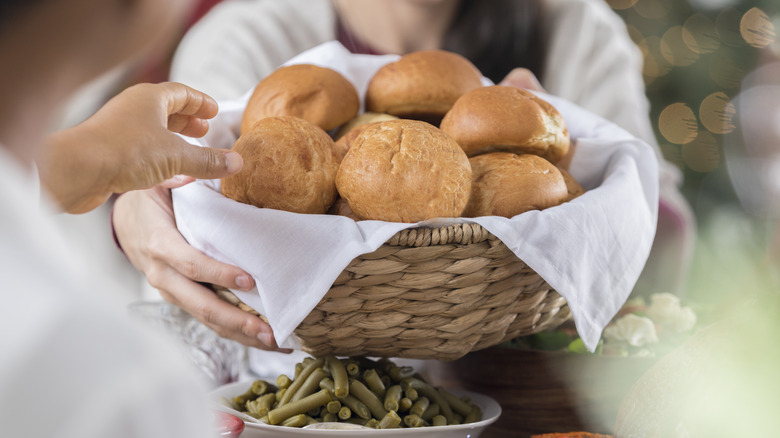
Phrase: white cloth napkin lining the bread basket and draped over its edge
[{"left": 173, "top": 42, "right": 658, "bottom": 351}]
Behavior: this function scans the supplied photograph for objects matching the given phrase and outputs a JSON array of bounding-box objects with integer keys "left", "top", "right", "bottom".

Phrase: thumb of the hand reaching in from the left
[{"left": 170, "top": 142, "right": 244, "bottom": 179}]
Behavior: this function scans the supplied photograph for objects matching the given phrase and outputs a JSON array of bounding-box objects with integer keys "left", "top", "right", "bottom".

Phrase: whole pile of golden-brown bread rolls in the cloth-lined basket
[{"left": 222, "top": 50, "right": 584, "bottom": 223}]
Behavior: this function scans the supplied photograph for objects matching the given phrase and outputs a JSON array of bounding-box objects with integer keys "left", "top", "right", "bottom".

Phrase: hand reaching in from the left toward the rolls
[{"left": 38, "top": 82, "right": 243, "bottom": 213}]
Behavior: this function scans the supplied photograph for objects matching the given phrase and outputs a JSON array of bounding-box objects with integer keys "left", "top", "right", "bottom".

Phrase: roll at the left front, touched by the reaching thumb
[{"left": 222, "top": 116, "right": 339, "bottom": 213}]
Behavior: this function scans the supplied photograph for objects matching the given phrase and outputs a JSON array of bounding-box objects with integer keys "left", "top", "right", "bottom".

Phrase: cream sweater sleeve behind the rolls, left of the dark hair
[{"left": 171, "top": 0, "right": 336, "bottom": 100}]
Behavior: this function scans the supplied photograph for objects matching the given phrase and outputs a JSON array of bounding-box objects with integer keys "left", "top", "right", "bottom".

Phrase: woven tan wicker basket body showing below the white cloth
[{"left": 218, "top": 224, "right": 571, "bottom": 360}]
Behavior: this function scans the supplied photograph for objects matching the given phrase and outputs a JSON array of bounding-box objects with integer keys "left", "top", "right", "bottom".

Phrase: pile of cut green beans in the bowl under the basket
[{"left": 225, "top": 356, "right": 482, "bottom": 429}]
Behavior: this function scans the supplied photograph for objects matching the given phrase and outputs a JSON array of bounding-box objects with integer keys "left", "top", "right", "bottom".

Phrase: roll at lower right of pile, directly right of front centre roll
[{"left": 463, "top": 152, "right": 569, "bottom": 218}]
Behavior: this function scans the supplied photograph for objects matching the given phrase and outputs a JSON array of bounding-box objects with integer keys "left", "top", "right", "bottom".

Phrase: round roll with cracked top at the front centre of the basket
[{"left": 336, "top": 120, "right": 471, "bottom": 223}]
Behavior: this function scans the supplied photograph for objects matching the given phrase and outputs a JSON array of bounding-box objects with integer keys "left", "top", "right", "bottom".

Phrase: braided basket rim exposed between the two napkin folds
[{"left": 384, "top": 222, "right": 496, "bottom": 248}]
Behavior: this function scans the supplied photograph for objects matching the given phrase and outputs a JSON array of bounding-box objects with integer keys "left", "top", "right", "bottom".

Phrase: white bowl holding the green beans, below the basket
[{"left": 211, "top": 381, "right": 501, "bottom": 438}]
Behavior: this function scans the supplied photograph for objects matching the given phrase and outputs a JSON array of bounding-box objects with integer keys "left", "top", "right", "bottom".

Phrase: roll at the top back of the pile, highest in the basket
[{"left": 366, "top": 50, "right": 482, "bottom": 125}]
